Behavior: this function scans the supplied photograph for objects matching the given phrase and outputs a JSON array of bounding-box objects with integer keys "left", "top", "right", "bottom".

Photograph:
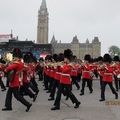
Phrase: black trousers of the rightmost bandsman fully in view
[{"left": 101, "top": 81, "right": 117, "bottom": 99}]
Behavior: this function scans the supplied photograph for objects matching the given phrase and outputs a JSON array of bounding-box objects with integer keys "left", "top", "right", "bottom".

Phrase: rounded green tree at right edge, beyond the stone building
[{"left": 108, "top": 45, "right": 120, "bottom": 57}]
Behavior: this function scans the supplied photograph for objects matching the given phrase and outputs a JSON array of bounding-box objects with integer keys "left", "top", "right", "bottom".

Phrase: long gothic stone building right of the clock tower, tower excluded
[{"left": 51, "top": 36, "right": 101, "bottom": 59}]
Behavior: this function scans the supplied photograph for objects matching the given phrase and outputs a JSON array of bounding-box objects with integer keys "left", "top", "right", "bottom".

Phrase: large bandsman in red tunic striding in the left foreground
[{"left": 2, "top": 48, "right": 32, "bottom": 112}]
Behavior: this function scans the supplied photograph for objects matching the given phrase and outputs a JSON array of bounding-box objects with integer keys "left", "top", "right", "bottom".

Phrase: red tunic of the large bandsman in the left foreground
[{"left": 6, "top": 60, "right": 23, "bottom": 87}]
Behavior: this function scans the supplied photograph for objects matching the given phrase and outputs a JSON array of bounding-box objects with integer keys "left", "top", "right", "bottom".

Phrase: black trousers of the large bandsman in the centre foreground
[{"left": 54, "top": 83, "right": 79, "bottom": 107}]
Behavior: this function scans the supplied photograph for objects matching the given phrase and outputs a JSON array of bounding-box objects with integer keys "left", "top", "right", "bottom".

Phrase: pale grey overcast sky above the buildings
[{"left": 0, "top": 0, "right": 120, "bottom": 55}]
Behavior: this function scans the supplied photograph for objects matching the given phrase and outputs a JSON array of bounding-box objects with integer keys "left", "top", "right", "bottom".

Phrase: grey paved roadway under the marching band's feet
[{"left": 0, "top": 79, "right": 120, "bottom": 120}]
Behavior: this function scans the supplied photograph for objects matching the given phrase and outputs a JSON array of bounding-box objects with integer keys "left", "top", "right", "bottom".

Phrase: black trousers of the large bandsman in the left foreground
[{"left": 5, "top": 87, "right": 30, "bottom": 108}]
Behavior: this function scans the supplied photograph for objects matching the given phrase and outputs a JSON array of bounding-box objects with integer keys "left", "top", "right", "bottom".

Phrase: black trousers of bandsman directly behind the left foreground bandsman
[{"left": 20, "top": 83, "right": 35, "bottom": 98}]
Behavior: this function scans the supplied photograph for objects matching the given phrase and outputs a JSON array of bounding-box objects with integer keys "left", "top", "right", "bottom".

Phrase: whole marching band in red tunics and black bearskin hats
[{"left": 0, "top": 48, "right": 120, "bottom": 112}]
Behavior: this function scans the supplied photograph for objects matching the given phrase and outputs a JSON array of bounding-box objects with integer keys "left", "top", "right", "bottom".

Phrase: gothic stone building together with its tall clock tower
[{"left": 37, "top": 0, "right": 101, "bottom": 59}]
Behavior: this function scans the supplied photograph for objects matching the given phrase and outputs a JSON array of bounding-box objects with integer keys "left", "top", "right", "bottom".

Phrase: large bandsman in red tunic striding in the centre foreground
[{"left": 51, "top": 49, "right": 80, "bottom": 110}]
